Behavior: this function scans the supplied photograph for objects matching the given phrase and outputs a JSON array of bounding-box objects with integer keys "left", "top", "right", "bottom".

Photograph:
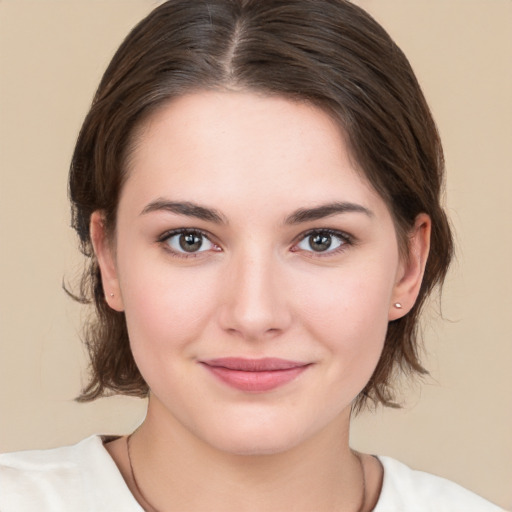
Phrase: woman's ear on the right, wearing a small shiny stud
[{"left": 388, "top": 213, "right": 432, "bottom": 321}]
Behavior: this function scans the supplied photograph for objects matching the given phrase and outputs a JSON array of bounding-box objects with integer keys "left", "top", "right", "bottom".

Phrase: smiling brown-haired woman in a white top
[{"left": 0, "top": 0, "right": 504, "bottom": 511}]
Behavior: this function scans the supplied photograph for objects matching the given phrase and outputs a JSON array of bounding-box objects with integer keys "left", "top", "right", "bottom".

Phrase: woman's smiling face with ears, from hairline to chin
[{"left": 92, "top": 92, "right": 428, "bottom": 454}]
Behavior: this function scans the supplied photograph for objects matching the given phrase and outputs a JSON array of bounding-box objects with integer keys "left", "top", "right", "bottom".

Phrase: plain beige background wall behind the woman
[{"left": 0, "top": 0, "right": 512, "bottom": 507}]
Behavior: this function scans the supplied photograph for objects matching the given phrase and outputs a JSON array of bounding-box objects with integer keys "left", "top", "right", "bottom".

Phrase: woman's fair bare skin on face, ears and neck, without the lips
[{"left": 91, "top": 91, "right": 430, "bottom": 511}]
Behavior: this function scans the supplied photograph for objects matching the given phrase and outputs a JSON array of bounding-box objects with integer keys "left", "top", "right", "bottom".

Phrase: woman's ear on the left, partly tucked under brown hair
[{"left": 90, "top": 210, "right": 124, "bottom": 311}]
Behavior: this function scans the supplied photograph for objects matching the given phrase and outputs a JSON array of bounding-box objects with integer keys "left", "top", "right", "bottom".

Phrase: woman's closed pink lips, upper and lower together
[{"left": 200, "top": 357, "right": 311, "bottom": 393}]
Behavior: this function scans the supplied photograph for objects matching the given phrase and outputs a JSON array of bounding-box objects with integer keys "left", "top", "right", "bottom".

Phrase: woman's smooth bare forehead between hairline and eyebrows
[{"left": 121, "top": 91, "right": 388, "bottom": 220}]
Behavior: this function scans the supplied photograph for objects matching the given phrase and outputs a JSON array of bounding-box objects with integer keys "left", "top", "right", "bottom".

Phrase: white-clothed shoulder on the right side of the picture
[{"left": 374, "top": 456, "right": 502, "bottom": 512}]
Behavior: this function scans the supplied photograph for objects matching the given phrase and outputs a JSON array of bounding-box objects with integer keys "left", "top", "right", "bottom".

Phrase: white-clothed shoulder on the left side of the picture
[{"left": 0, "top": 436, "right": 142, "bottom": 512}]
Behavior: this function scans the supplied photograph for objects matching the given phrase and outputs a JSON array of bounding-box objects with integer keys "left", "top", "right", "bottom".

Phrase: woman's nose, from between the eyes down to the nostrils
[{"left": 220, "top": 247, "right": 291, "bottom": 341}]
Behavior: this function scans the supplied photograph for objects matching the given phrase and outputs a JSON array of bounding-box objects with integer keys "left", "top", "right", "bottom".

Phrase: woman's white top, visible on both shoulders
[{"left": 0, "top": 436, "right": 502, "bottom": 512}]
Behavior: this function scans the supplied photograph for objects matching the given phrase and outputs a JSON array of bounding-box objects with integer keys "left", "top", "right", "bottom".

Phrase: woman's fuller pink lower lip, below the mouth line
[{"left": 203, "top": 364, "right": 309, "bottom": 393}]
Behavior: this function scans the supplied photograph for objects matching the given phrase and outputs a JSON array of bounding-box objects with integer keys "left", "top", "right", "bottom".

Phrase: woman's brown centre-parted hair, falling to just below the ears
[{"left": 69, "top": 0, "right": 453, "bottom": 410}]
